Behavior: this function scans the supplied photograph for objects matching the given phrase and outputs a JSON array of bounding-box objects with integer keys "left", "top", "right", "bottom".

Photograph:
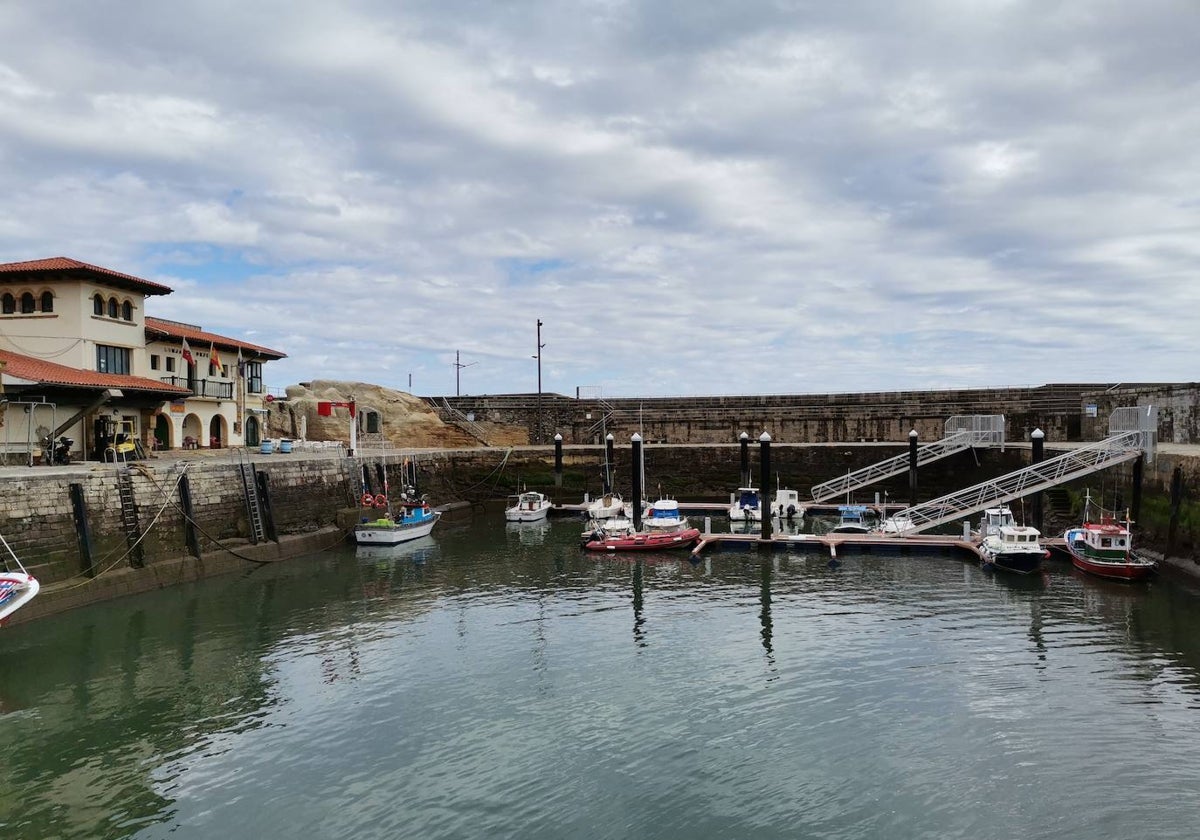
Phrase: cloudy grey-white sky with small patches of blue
[{"left": 0, "top": 0, "right": 1200, "bottom": 397}]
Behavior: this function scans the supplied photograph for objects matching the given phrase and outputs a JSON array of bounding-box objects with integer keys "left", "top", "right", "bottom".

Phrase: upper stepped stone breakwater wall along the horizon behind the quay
[{"left": 428, "top": 383, "right": 1200, "bottom": 444}]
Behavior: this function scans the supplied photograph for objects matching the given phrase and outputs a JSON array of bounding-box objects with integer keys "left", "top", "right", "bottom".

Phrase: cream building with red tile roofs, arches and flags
[{"left": 0, "top": 257, "right": 286, "bottom": 461}]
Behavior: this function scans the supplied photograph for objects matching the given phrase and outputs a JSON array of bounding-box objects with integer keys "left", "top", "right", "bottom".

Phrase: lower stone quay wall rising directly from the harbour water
[{"left": 0, "top": 444, "right": 1200, "bottom": 620}]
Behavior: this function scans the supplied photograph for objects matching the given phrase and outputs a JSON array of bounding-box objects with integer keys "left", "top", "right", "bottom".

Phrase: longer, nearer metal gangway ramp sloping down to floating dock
[{"left": 900, "top": 406, "right": 1158, "bottom": 534}]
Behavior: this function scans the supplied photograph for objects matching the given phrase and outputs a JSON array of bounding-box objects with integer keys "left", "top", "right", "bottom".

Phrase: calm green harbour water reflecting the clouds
[{"left": 0, "top": 512, "right": 1200, "bottom": 840}]
